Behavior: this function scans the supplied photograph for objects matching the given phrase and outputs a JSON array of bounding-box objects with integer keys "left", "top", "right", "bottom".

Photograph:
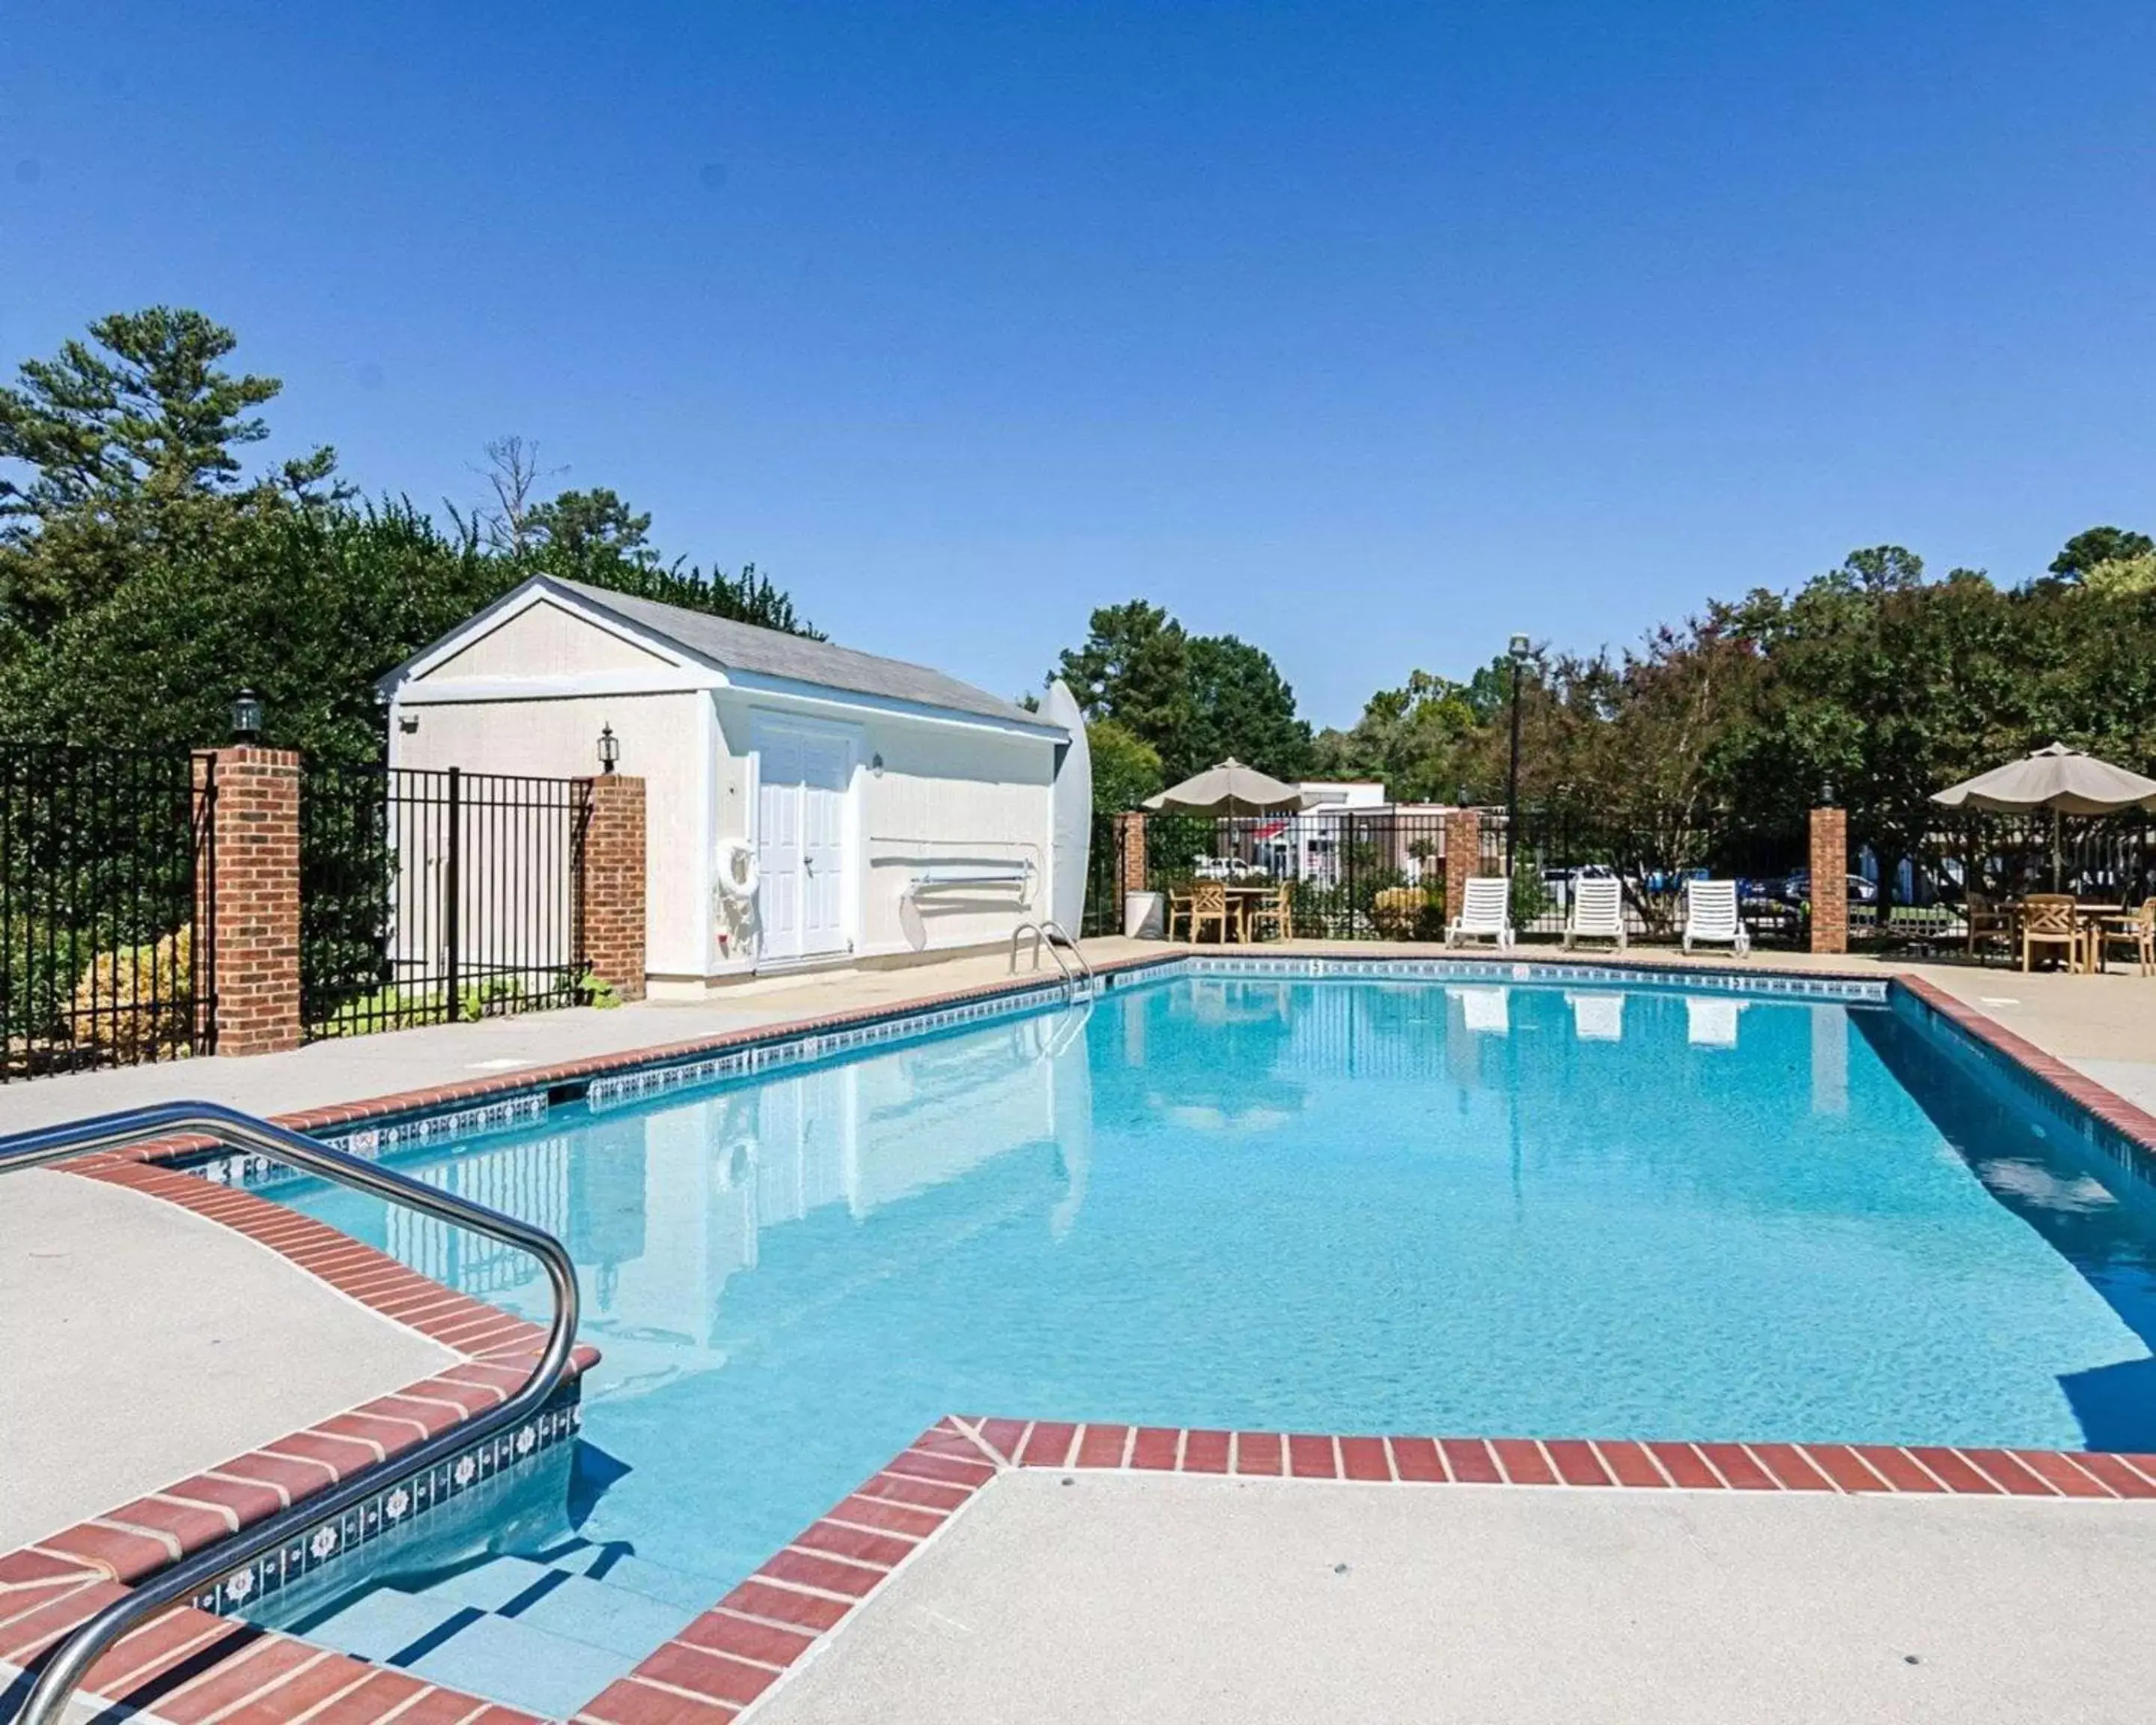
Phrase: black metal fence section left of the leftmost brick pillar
[{"left": 0, "top": 742, "right": 218, "bottom": 1083}]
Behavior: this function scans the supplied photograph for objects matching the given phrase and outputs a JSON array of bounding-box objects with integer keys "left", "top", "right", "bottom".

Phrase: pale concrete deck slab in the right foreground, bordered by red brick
[{"left": 746, "top": 1470, "right": 2156, "bottom": 1725}]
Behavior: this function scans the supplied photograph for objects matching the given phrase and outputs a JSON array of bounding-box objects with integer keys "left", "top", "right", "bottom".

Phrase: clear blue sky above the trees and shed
[{"left": 0, "top": 0, "right": 2156, "bottom": 722}]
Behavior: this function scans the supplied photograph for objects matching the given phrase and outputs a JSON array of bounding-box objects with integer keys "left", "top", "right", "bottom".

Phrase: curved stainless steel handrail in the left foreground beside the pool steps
[{"left": 0, "top": 1102, "right": 576, "bottom": 1725}]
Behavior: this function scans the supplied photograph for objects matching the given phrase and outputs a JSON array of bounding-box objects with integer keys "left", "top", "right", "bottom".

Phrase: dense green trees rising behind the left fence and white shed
[{"left": 0, "top": 308, "right": 813, "bottom": 759}]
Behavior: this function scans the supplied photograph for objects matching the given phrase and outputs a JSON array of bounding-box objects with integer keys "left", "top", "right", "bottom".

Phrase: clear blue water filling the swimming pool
[{"left": 278, "top": 977, "right": 2156, "bottom": 1598}]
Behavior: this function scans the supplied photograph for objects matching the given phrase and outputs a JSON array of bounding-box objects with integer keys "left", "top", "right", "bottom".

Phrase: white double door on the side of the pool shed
[{"left": 755, "top": 720, "right": 853, "bottom": 964}]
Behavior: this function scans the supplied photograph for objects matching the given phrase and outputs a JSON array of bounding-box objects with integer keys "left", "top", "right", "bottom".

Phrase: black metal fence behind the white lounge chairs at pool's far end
[{"left": 1085, "top": 809, "right": 1809, "bottom": 944}]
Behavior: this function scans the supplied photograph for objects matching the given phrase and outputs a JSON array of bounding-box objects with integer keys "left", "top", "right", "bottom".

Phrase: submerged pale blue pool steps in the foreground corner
[{"left": 297, "top": 1542, "right": 718, "bottom": 1718}]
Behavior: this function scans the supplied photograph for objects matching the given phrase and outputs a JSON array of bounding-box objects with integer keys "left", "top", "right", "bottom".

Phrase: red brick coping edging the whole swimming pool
[{"left": 12, "top": 949, "right": 2156, "bottom": 1725}]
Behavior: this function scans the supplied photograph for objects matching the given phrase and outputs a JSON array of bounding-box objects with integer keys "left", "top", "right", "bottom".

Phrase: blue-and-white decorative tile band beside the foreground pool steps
[{"left": 192, "top": 1378, "right": 584, "bottom": 1617}]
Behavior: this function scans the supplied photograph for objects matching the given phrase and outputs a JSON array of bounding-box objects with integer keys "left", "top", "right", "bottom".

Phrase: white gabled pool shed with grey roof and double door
[{"left": 380, "top": 576, "right": 1087, "bottom": 997}]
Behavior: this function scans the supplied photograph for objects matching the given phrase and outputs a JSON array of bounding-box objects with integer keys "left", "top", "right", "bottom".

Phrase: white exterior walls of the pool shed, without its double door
[{"left": 390, "top": 582, "right": 1056, "bottom": 992}]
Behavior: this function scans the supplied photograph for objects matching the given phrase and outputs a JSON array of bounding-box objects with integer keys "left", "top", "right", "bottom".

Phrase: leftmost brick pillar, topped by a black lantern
[{"left": 196, "top": 744, "right": 299, "bottom": 1054}]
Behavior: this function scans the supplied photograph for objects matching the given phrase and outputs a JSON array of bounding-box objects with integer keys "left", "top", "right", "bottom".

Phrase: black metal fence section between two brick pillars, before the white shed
[{"left": 299, "top": 767, "right": 591, "bottom": 1039}]
